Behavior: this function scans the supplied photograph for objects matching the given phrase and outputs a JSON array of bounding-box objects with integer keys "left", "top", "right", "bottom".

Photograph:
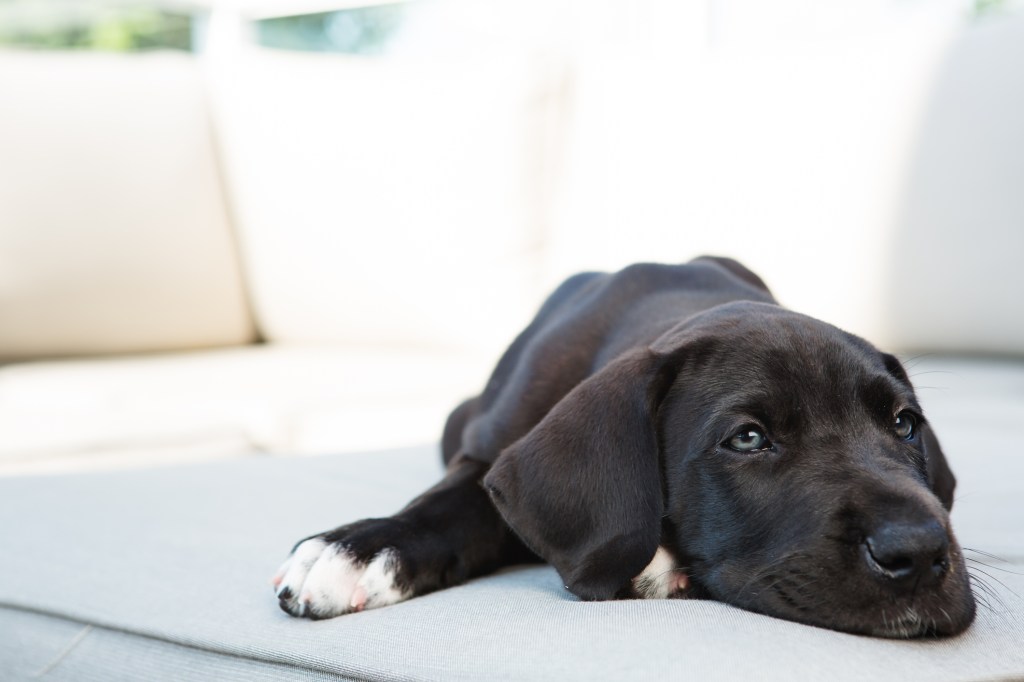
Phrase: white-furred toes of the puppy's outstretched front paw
[{"left": 273, "top": 538, "right": 412, "bottom": 619}]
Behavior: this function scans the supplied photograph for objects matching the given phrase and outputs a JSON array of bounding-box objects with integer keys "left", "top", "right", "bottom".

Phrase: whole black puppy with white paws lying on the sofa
[{"left": 274, "top": 258, "right": 975, "bottom": 637}]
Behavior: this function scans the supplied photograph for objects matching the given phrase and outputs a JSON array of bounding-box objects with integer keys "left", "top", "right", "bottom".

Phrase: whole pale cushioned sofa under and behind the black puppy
[{"left": 0, "top": 7, "right": 1024, "bottom": 682}]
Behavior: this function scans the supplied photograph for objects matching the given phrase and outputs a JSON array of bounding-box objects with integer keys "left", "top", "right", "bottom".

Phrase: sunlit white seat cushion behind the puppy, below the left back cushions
[{"left": 0, "top": 345, "right": 493, "bottom": 474}]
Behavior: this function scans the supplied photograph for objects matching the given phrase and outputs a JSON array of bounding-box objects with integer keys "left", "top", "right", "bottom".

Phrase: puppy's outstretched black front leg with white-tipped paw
[{"left": 273, "top": 456, "right": 535, "bottom": 619}]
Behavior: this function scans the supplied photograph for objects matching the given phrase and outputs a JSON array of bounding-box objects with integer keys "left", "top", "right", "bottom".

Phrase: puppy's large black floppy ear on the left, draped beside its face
[{"left": 483, "top": 330, "right": 682, "bottom": 599}]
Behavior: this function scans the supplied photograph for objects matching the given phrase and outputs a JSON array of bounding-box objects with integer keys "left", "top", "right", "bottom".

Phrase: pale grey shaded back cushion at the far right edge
[{"left": 882, "top": 15, "right": 1024, "bottom": 354}]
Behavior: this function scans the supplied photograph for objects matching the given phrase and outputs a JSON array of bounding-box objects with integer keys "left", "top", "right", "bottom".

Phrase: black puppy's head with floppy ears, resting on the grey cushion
[{"left": 484, "top": 303, "right": 975, "bottom": 637}]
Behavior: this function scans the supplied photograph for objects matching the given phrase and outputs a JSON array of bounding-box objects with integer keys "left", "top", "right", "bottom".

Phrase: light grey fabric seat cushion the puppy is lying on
[{"left": 0, "top": 352, "right": 1024, "bottom": 682}]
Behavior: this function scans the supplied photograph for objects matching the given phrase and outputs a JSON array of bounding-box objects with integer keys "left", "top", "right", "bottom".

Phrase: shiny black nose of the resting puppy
[{"left": 864, "top": 520, "right": 949, "bottom": 587}]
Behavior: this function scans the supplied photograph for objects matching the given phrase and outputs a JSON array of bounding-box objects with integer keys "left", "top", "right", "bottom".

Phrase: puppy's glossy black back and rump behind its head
[{"left": 441, "top": 256, "right": 775, "bottom": 464}]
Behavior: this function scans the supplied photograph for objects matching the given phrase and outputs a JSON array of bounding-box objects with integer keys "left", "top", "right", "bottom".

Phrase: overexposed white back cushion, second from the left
[{"left": 213, "top": 50, "right": 569, "bottom": 352}]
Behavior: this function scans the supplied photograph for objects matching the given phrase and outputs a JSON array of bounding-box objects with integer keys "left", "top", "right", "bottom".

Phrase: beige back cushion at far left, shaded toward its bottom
[{"left": 0, "top": 52, "right": 253, "bottom": 358}]
